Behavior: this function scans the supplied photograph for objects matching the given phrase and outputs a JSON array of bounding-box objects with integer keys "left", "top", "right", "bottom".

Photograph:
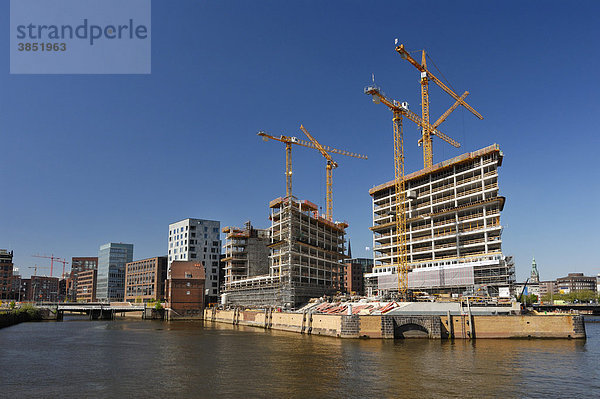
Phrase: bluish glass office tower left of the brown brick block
[{"left": 96, "top": 242, "right": 133, "bottom": 302}]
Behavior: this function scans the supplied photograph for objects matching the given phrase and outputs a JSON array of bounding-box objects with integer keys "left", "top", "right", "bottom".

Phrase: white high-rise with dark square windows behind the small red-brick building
[{"left": 168, "top": 218, "right": 221, "bottom": 302}]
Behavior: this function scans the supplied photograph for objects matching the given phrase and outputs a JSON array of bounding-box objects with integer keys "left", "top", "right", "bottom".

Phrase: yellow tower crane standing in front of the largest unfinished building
[{"left": 364, "top": 86, "right": 460, "bottom": 299}]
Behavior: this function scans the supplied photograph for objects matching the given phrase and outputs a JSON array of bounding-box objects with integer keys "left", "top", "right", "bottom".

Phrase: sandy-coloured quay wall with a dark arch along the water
[{"left": 204, "top": 308, "right": 586, "bottom": 339}]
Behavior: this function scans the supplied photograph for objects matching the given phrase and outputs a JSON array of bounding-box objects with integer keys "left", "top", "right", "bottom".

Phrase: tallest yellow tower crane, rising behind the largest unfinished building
[{"left": 396, "top": 44, "right": 483, "bottom": 168}]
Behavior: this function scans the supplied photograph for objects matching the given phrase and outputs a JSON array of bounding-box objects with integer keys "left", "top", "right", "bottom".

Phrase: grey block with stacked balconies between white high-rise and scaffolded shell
[{"left": 222, "top": 222, "right": 271, "bottom": 290}]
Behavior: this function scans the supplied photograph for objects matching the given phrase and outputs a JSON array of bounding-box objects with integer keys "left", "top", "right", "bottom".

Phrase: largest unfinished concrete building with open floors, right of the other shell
[{"left": 365, "top": 144, "right": 514, "bottom": 295}]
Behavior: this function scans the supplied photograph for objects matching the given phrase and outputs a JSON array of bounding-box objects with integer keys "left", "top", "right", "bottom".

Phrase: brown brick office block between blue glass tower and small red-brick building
[{"left": 125, "top": 256, "right": 167, "bottom": 302}]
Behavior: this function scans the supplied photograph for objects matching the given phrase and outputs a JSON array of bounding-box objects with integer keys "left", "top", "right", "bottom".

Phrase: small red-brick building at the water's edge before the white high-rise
[{"left": 165, "top": 261, "right": 206, "bottom": 320}]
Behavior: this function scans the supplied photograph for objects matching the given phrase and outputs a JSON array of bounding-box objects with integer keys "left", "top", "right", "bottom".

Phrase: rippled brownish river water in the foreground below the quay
[{"left": 0, "top": 319, "right": 600, "bottom": 398}]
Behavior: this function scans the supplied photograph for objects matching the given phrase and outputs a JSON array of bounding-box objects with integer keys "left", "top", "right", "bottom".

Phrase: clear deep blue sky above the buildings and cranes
[{"left": 0, "top": 0, "right": 600, "bottom": 280}]
